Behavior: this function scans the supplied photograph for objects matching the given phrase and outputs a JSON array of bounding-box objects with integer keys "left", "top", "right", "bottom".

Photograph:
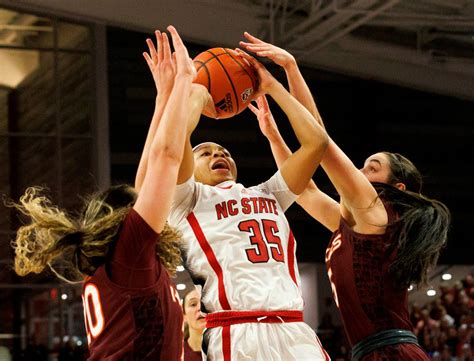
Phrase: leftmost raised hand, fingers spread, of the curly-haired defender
[{"left": 143, "top": 30, "right": 176, "bottom": 95}]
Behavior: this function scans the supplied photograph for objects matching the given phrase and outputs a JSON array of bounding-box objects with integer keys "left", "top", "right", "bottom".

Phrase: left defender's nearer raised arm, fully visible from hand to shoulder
[{"left": 133, "top": 26, "right": 209, "bottom": 233}]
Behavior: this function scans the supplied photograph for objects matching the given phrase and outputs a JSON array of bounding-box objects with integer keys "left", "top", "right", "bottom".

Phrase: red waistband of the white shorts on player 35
[{"left": 206, "top": 311, "right": 303, "bottom": 328}]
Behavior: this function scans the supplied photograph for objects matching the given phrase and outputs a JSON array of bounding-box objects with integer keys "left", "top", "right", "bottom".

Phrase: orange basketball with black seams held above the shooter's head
[{"left": 193, "top": 48, "right": 258, "bottom": 119}]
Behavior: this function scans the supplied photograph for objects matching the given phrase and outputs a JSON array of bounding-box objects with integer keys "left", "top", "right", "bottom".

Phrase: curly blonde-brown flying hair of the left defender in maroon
[{"left": 6, "top": 185, "right": 181, "bottom": 282}]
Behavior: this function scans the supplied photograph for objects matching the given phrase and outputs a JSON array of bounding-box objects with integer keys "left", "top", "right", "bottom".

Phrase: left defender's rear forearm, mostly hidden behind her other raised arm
[{"left": 135, "top": 92, "right": 170, "bottom": 192}]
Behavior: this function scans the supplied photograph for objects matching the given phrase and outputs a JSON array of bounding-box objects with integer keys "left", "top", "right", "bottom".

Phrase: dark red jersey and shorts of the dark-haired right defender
[{"left": 326, "top": 201, "right": 428, "bottom": 361}]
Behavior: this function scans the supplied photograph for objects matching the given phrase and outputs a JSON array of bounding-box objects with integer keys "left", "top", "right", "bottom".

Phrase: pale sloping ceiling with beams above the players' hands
[{"left": 0, "top": 0, "right": 474, "bottom": 100}]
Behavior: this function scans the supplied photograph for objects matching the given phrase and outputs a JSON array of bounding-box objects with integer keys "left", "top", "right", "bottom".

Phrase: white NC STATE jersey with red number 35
[{"left": 169, "top": 172, "right": 303, "bottom": 312}]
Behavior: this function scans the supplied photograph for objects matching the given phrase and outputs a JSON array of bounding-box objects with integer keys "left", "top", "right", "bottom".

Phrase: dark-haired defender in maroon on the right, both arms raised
[{"left": 240, "top": 33, "right": 450, "bottom": 361}]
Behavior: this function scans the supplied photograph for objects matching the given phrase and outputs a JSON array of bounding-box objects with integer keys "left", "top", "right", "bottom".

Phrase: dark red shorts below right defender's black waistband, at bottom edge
[{"left": 360, "top": 343, "right": 430, "bottom": 361}]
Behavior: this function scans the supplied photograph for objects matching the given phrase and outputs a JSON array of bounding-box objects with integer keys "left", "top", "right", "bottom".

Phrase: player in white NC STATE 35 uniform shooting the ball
[{"left": 169, "top": 54, "right": 329, "bottom": 361}]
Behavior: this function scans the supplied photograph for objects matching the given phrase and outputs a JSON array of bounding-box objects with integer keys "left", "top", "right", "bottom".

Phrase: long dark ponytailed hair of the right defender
[{"left": 374, "top": 152, "right": 451, "bottom": 287}]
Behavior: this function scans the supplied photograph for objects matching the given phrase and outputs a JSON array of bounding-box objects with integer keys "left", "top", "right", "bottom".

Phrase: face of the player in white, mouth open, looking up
[{"left": 194, "top": 142, "right": 237, "bottom": 186}]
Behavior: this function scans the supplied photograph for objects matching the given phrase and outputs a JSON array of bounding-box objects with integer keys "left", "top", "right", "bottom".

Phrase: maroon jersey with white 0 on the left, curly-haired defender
[{"left": 83, "top": 209, "right": 183, "bottom": 361}]
